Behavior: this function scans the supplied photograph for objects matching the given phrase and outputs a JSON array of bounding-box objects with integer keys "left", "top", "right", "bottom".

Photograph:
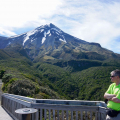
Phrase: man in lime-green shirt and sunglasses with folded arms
[{"left": 104, "top": 69, "right": 120, "bottom": 120}]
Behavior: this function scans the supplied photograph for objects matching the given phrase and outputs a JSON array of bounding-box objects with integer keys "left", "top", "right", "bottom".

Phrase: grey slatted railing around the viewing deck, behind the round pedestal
[{"left": 1, "top": 93, "right": 106, "bottom": 120}]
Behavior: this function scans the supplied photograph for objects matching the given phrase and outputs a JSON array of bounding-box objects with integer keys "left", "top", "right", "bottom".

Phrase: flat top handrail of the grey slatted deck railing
[{"left": 4, "top": 93, "right": 106, "bottom": 107}]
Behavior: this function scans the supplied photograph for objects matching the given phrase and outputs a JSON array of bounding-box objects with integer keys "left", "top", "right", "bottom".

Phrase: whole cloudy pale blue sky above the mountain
[{"left": 0, "top": 0, "right": 120, "bottom": 54}]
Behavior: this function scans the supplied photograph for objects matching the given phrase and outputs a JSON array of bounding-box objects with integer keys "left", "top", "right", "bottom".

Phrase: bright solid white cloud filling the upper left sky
[{"left": 0, "top": 0, "right": 61, "bottom": 27}]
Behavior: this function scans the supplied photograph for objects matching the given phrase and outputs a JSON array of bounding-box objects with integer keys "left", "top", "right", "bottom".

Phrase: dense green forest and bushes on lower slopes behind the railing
[{"left": 0, "top": 47, "right": 120, "bottom": 100}]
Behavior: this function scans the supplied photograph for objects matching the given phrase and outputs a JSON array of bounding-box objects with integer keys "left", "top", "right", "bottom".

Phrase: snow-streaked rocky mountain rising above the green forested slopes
[{"left": 0, "top": 23, "right": 117, "bottom": 60}]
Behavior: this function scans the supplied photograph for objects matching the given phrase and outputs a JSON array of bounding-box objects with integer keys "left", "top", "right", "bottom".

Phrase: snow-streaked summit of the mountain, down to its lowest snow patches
[{"left": 9, "top": 24, "right": 66, "bottom": 46}]
